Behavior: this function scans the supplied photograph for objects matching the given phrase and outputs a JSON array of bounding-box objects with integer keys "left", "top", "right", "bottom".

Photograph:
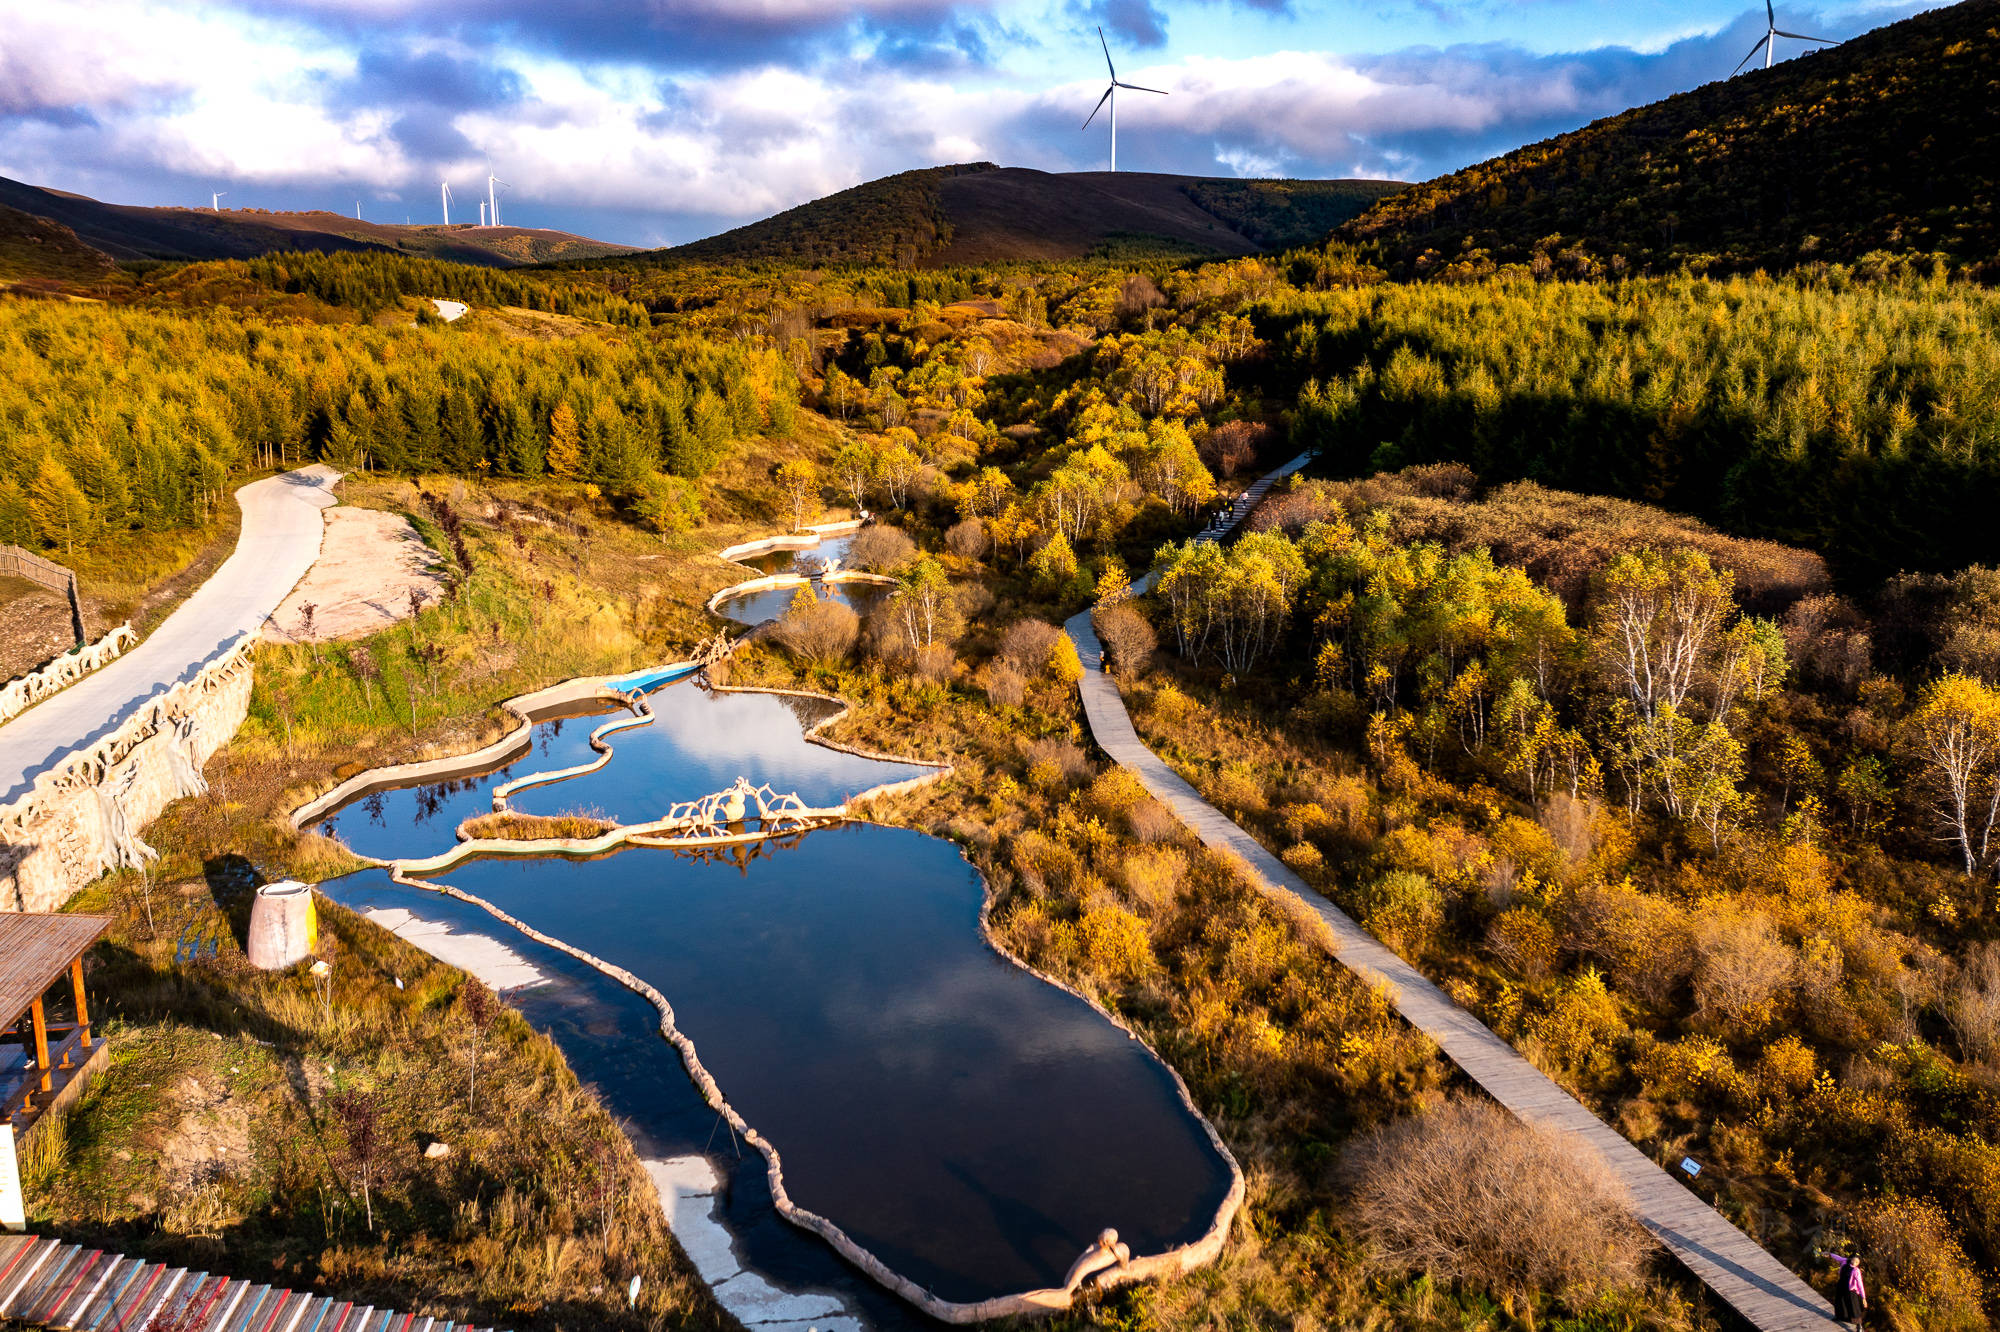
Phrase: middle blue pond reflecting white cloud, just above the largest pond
[{"left": 320, "top": 682, "right": 928, "bottom": 860}]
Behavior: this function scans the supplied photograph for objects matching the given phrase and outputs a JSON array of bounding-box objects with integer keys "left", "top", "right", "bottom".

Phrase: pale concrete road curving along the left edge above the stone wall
[{"left": 0, "top": 464, "right": 340, "bottom": 804}]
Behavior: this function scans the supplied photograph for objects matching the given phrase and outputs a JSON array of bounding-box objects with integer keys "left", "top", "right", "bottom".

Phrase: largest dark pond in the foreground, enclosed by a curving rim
[{"left": 336, "top": 824, "right": 1228, "bottom": 1300}]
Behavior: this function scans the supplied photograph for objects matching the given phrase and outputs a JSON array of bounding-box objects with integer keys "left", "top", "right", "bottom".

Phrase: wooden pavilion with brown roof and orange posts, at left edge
[{"left": 0, "top": 912, "right": 112, "bottom": 1230}]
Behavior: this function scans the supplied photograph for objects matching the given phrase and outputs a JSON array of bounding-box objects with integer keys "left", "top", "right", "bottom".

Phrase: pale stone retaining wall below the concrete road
[{"left": 0, "top": 634, "right": 254, "bottom": 912}]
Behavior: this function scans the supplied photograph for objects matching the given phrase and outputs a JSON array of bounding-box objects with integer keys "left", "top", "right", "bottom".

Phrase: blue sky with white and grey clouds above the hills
[{"left": 0, "top": 0, "right": 1930, "bottom": 246}]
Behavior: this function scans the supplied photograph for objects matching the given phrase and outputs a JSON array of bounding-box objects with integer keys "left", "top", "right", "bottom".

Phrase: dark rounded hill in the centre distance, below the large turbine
[{"left": 638, "top": 162, "right": 1402, "bottom": 268}]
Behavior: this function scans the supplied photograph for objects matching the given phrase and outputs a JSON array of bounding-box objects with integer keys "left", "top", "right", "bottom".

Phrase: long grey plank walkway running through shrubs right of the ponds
[{"left": 1064, "top": 458, "right": 1838, "bottom": 1332}]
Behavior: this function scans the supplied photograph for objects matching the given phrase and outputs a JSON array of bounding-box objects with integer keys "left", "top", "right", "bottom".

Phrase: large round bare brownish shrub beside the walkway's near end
[{"left": 1344, "top": 1100, "right": 1650, "bottom": 1306}]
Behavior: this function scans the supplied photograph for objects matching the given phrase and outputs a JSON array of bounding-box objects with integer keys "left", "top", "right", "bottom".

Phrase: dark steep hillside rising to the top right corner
[{"left": 1342, "top": 0, "right": 2000, "bottom": 276}]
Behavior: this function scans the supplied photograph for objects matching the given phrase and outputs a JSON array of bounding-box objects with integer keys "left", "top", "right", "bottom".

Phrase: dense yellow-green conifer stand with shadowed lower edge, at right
[{"left": 1260, "top": 274, "right": 2000, "bottom": 584}]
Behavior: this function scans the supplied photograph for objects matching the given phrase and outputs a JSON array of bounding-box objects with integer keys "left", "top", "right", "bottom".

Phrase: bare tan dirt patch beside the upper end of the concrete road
[{"left": 272, "top": 504, "right": 444, "bottom": 642}]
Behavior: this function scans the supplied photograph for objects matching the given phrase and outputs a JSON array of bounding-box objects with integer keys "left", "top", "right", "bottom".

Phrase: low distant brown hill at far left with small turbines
[{"left": 0, "top": 178, "right": 626, "bottom": 276}]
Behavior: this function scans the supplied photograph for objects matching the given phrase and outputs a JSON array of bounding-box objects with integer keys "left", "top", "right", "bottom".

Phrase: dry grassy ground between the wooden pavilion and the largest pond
[{"left": 37, "top": 870, "right": 726, "bottom": 1330}]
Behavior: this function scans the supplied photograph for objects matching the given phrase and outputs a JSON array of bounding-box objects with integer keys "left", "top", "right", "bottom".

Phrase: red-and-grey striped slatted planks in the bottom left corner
[{"left": 0, "top": 1234, "right": 504, "bottom": 1332}]
